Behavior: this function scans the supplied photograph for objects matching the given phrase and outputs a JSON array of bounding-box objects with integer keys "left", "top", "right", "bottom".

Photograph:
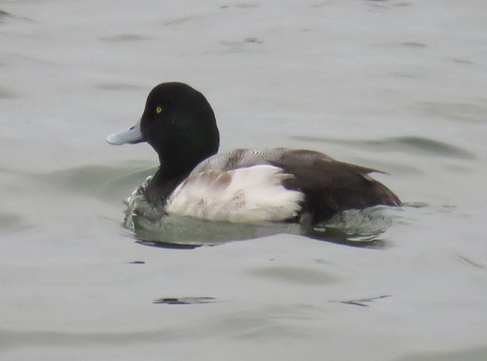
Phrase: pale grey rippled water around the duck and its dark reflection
[{"left": 0, "top": 0, "right": 487, "bottom": 361}]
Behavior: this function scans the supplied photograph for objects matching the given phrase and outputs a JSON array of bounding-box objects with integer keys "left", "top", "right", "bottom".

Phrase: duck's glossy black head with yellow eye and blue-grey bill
[{"left": 107, "top": 82, "right": 220, "bottom": 173}]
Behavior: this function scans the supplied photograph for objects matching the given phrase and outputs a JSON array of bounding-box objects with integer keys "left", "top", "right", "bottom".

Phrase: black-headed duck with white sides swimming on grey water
[{"left": 106, "top": 82, "right": 402, "bottom": 225}]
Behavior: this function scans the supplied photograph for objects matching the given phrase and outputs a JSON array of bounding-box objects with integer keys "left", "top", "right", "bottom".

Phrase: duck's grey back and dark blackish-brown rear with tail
[{"left": 192, "top": 148, "right": 401, "bottom": 223}]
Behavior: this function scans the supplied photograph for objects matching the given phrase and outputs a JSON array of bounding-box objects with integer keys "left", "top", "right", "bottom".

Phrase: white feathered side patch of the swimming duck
[{"left": 166, "top": 165, "right": 304, "bottom": 222}]
